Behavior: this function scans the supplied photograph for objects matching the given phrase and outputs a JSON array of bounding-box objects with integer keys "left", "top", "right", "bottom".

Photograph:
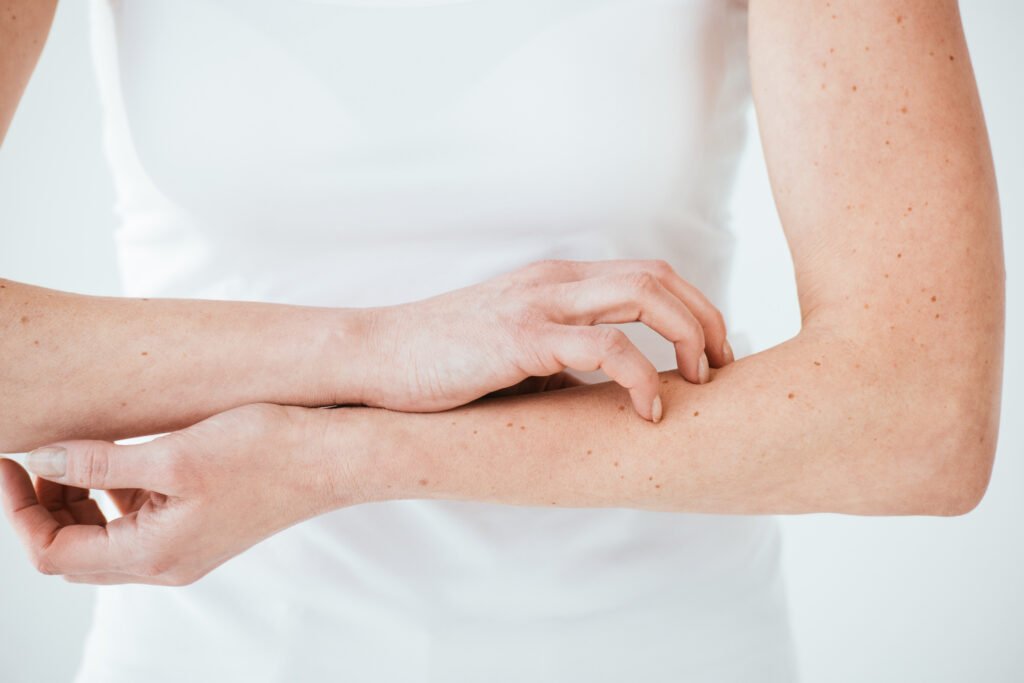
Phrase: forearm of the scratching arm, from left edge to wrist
[{"left": 0, "top": 280, "right": 365, "bottom": 453}]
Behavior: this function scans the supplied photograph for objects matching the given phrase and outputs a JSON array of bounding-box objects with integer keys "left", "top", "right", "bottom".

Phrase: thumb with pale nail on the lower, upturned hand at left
[{"left": 26, "top": 439, "right": 170, "bottom": 493}]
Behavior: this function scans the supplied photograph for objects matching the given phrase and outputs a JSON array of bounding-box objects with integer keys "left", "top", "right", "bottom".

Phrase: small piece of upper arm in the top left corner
[{"left": 0, "top": 0, "right": 57, "bottom": 142}]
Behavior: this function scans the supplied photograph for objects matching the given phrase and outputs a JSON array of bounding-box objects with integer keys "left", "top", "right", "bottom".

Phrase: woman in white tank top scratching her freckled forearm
[{"left": 0, "top": 0, "right": 1004, "bottom": 681}]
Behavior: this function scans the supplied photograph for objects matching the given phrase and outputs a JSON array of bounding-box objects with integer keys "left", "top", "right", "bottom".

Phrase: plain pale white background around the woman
[{"left": 0, "top": 0, "right": 1024, "bottom": 683}]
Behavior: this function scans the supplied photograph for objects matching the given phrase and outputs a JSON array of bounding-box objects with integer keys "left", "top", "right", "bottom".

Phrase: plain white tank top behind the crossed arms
[{"left": 78, "top": 0, "right": 796, "bottom": 683}]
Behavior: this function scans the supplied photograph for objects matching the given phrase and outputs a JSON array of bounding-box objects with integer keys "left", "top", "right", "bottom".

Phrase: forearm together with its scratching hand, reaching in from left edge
[{"left": 0, "top": 261, "right": 732, "bottom": 453}]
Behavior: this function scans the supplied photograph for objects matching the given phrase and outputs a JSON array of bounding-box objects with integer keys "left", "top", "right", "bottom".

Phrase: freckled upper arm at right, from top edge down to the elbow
[{"left": 750, "top": 0, "right": 1005, "bottom": 499}]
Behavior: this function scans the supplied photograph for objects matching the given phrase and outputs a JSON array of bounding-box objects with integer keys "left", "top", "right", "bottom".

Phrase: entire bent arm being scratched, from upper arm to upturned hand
[{"left": 0, "top": 0, "right": 1006, "bottom": 585}]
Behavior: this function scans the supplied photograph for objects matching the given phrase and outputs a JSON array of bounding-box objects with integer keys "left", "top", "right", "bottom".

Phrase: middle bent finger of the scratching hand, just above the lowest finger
[{"left": 560, "top": 270, "right": 711, "bottom": 384}]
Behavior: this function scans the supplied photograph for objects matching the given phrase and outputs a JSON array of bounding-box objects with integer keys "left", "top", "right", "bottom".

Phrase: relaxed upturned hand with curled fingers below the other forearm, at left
[{"left": 0, "top": 403, "right": 361, "bottom": 586}]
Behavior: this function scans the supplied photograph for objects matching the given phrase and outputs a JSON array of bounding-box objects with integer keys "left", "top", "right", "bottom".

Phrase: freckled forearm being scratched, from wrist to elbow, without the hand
[{"left": 339, "top": 326, "right": 992, "bottom": 514}]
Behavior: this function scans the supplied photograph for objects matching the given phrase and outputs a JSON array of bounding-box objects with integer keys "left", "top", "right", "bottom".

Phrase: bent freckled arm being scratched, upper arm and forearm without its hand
[{"left": 329, "top": 0, "right": 1005, "bottom": 514}]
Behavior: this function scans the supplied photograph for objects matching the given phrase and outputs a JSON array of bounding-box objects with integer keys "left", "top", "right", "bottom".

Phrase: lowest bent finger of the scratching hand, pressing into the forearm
[{"left": 547, "top": 325, "right": 662, "bottom": 422}]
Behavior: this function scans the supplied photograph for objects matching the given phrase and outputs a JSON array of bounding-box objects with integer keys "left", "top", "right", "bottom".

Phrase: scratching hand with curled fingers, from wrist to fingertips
[{"left": 362, "top": 261, "right": 733, "bottom": 422}]
